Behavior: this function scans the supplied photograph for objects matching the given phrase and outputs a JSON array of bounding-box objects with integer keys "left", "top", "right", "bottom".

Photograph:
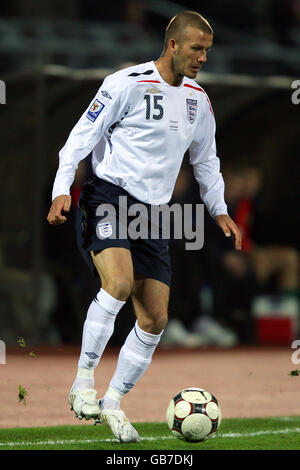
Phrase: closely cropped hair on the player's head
[{"left": 164, "top": 10, "right": 213, "bottom": 49}]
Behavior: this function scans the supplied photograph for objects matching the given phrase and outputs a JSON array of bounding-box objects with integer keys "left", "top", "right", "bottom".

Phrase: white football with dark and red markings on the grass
[{"left": 167, "top": 387, "right": 222, "bottom": 442}]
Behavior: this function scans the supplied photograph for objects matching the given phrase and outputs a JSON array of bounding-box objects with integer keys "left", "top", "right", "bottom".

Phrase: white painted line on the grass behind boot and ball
[{"left": 0, "top": 428, "right": 300, "bottom": 447}]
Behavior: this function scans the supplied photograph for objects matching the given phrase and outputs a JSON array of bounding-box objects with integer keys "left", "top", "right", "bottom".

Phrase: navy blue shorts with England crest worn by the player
[{"left": 76, "top": 177, "right": 172, "bottom": 286}]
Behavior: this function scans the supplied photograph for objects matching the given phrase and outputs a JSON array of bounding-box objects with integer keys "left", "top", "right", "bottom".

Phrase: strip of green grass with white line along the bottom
[{"left": 0, "top": 416, "right": 300, "bottom": 451}]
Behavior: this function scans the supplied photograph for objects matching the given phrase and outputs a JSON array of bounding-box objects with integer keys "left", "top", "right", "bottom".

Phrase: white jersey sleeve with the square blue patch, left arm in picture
[{"left": 52, "top": 77, "right": 129, "bottom": 200}]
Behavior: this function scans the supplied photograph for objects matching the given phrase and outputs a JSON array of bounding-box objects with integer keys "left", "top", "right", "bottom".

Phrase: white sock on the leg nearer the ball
[{"left": 102, "top": 322, "right": 163, "bottom": 408}]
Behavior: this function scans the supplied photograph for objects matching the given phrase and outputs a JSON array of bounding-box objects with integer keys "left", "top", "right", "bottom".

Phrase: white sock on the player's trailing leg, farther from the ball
[{"left": 73, "top": 289, "right": 125, "bottom": 389}]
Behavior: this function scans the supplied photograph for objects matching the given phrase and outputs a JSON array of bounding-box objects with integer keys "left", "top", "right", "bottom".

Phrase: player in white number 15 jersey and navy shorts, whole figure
[{"left": 47, "top": 11, "right": 241, "bottom": 442}]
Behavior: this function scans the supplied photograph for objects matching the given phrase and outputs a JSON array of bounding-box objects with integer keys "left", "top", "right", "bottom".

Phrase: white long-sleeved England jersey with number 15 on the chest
[{"left": 52, "top": 61, "right": 227, "bottom": 217}]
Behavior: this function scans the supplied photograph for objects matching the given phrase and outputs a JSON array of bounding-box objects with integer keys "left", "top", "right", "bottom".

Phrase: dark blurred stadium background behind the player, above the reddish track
[{"left": 0, "top": 0, "right": 300, "bottom": 348}]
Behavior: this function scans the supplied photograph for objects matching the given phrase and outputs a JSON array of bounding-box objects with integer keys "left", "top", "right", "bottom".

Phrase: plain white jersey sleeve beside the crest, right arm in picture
[{"left": 189, "top": 99, "right": 227, "bottom": 217}]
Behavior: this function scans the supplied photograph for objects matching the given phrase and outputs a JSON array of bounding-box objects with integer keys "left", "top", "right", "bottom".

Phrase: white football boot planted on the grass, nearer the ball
[{"left": 98, "top": 400, "right": 141, "bottom": 442}]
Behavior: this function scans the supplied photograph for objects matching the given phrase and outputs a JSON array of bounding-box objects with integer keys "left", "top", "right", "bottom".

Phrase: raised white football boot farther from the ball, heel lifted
[{"left": 68, "top": 388, "right": 100, "bottom": 420}]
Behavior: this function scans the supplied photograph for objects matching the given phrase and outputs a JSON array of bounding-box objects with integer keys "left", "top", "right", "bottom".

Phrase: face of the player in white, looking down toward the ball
[{"left": 173, "top": 26, "right": 213, "bottom": 79}]
